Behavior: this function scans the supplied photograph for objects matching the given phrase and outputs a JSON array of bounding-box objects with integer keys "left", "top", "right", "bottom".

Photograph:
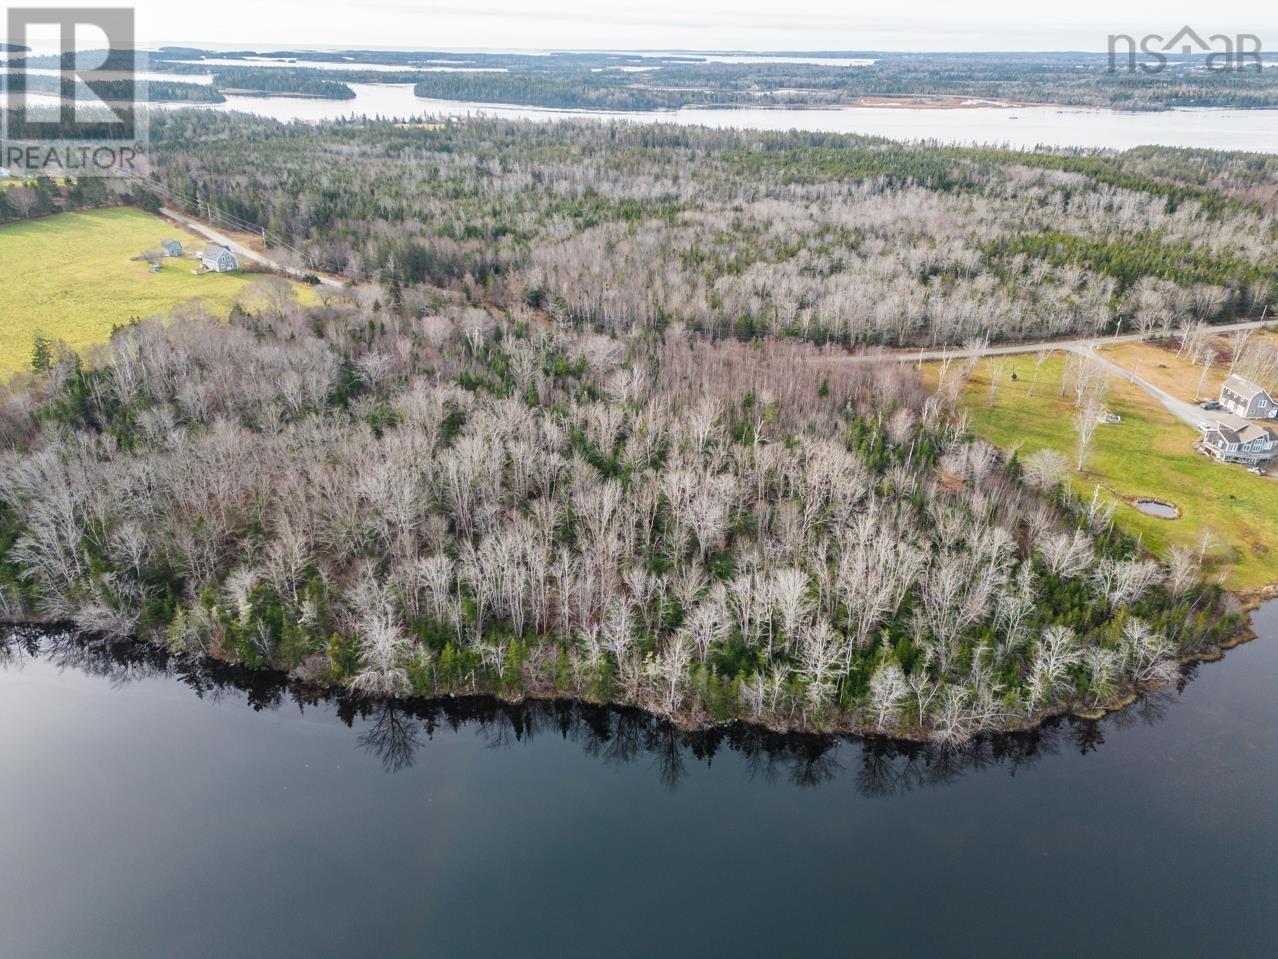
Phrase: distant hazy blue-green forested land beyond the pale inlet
[{"left": 158, "top": 50, "right": 1278, "bottom": 110}]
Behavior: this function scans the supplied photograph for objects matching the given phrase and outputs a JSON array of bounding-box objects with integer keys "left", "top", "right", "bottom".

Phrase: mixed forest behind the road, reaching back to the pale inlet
[{"left": 151, "top": 111, "right": 1278, "bottom": 347}]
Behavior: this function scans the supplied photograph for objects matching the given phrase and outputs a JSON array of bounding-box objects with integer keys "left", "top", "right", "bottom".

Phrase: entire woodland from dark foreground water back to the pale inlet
[{"left": 0, "top": 111, "right": 1278, "bottom": 743}]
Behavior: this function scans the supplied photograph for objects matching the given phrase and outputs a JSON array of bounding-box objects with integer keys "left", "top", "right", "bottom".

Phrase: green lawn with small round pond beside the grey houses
[{"left": 932, "top": 354, "right": 1278, "bottom": 589}]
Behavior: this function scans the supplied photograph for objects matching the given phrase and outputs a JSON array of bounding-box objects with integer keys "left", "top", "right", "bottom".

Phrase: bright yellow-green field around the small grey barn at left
[{"left": 0, "top": 208, "right": 308, "bottom": 377}]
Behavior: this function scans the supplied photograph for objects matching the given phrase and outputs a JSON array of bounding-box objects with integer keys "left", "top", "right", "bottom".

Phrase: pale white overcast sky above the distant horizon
[{"left": 7, "top": 0, "right": 1278, "bottom": 51}]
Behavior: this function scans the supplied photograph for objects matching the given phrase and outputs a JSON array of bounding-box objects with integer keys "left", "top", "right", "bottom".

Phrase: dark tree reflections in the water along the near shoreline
[{"left": 0, "top": 627, "right": 1175, "bottom": 797}]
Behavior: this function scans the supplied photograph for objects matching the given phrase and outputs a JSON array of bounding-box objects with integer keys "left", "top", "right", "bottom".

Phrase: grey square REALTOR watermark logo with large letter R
[{"left": 0, "top": 6, "right": 146, "bottom": 176}]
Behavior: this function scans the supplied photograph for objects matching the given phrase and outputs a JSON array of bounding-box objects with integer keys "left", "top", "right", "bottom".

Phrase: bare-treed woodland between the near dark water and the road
[{"left": 0, "top": 292, "right": 1237, "bottom": 742}]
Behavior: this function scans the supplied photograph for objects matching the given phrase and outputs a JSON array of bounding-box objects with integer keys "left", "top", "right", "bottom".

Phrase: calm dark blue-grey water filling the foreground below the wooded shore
[{"left": 0, "top": 604, "right": 1278, "bottom": 959}]
